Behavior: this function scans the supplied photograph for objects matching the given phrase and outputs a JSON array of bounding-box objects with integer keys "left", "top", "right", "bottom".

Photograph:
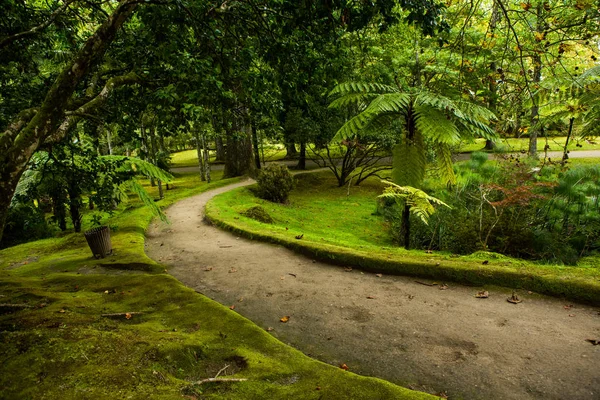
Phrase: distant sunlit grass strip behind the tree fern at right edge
[{"left": 458, "top": 136, "right": 600, "bottom": 153}]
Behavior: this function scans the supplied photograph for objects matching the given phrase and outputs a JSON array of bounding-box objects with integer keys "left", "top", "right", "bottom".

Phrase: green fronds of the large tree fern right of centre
[{"left": 330, "top": 83, "right": 496, "bottom": 187}]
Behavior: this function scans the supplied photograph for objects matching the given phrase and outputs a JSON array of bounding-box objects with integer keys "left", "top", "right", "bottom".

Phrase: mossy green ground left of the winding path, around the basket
[{"left": 0, "top": 170, "right": 432, "bottom": 399}]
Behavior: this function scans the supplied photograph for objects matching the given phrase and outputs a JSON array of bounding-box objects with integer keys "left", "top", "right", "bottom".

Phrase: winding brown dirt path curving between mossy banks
[{"left": 146, "top": 181, "right": 600, "bottom": 400}]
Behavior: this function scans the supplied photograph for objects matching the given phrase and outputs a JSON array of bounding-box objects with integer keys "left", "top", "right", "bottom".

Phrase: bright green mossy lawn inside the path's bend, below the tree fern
[{"left": 206, "top": 172, "right": 600, "bottom": 304}]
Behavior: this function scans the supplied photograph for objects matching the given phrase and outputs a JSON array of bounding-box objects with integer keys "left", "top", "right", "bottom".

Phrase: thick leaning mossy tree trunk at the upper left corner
[{"left": 0, "top": 0, "right": 139, "bottom": 241}]
